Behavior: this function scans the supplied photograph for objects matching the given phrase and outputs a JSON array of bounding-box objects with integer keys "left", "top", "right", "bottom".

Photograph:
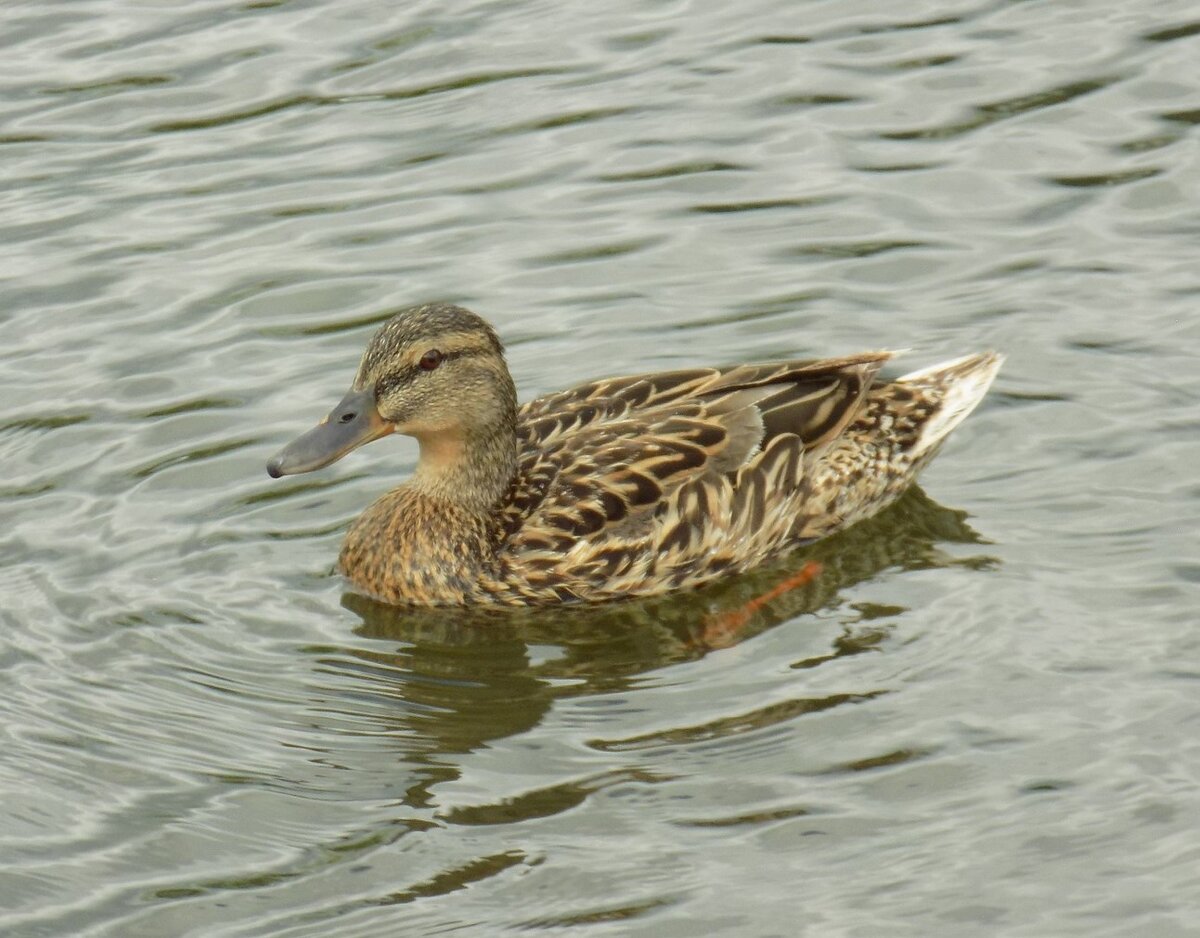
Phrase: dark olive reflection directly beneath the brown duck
[{"left": 322, "top": 487, "right": 995, "bottom": 786}]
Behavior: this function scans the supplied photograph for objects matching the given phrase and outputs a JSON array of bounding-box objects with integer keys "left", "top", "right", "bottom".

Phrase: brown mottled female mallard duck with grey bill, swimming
[{"left": 266, "top": 303, "right": 1002, "bottom": 606}]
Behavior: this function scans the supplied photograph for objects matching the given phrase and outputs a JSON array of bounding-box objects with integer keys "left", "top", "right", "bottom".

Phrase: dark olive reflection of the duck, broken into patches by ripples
[{"left": 316, "top": 487, "right": 994, "bottom": 824}]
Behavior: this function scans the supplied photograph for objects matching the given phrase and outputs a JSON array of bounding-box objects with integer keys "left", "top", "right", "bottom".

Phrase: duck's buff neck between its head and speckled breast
[{"left": 408, "top": 421, "right": 517, "bottom": 516}]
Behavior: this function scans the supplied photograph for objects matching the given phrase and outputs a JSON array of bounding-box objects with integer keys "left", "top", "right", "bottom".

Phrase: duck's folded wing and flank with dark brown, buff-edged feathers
[{"left": 500, "top": 351, "right": 892, "bottom": 599}]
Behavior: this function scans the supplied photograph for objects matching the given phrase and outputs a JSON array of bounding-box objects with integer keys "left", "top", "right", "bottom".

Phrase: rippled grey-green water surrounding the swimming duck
[{"left": 0, "top": 0, "right": 1200, "bottom": 938}]
